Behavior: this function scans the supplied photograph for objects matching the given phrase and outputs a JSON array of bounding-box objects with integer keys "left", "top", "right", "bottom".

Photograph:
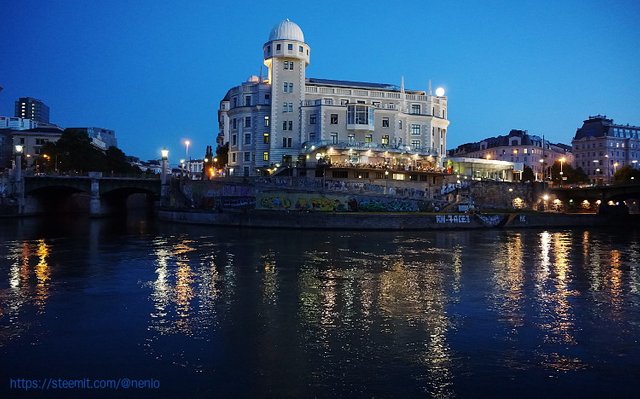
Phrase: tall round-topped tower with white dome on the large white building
[{"left": 263, "top": 19, "right": 311, "bottom": 164}]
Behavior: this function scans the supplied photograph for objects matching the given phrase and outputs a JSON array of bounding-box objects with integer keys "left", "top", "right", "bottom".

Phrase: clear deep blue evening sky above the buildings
[{"left": 0, "top": 0, "right": 640, "bottom": 162}]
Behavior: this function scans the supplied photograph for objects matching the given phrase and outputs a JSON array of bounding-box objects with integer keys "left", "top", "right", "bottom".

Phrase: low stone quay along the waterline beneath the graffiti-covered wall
[{"left": 158, "top": 209, "right": 639, "bottom": 230}]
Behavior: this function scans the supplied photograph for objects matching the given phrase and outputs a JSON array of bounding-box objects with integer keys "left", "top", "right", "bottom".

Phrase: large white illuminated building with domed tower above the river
[{"left": 218, "top": 20, "right": 449, "bottom": 176}]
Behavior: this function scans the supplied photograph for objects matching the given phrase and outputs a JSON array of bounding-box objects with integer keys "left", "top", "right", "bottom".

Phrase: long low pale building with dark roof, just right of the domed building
[{"left": 448, "top": 129, "right": 573, "bottom": 181}]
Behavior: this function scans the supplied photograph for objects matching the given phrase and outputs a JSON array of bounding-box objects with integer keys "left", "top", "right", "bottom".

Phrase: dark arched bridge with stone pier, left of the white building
[{"left": 18, "top": 172, "right": 162, "bottom": 216}]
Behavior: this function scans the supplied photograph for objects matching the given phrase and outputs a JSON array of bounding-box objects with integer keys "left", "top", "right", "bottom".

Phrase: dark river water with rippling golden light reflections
[{"left": 0, "top": 218, "right": 640, "bottom": 398}]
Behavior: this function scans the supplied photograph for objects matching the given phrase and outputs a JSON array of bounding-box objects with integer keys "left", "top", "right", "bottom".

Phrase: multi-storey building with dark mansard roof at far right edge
[{"left": 571, "top": 115, "right": 640, "bottom": 184}]
